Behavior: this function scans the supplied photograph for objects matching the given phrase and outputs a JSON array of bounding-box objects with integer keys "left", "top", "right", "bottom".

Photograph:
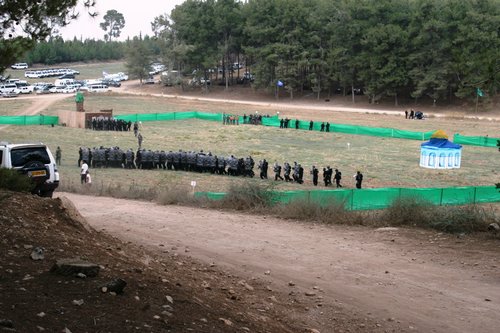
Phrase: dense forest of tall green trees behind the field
[{"left": 19, "top": 0, "right": 500, "bottom": 104}]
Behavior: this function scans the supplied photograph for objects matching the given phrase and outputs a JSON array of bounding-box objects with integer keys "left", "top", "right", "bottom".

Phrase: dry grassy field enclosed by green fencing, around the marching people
[{"left": 1, "top": 115, "right": 500, "bottom": 192}]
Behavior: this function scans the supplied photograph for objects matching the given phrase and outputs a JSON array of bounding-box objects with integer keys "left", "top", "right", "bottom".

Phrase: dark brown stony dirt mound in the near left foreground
[{"left": 0, "top": 192, "right": 311, "bottom": 333}]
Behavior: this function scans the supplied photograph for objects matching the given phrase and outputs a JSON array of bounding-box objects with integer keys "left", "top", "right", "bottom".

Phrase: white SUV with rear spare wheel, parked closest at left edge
[{"left": 0, "top": 142, "right": 59, "bottom": 198}]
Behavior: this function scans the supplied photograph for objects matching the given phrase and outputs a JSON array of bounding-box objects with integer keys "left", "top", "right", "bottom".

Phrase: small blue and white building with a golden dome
[{"left": 420, "top": 130, "right": 462, "bottom": 169}]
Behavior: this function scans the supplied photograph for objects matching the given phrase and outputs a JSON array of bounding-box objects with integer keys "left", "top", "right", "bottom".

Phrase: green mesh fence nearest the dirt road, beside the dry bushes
[{"left": 195, "top": 186, "right": 500, "bottom": 210}]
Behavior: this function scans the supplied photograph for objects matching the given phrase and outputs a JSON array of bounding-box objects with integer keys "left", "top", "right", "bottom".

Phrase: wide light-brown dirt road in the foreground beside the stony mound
[{"left": 60, "top": 193, "right": 500, "bottom": 333}]
